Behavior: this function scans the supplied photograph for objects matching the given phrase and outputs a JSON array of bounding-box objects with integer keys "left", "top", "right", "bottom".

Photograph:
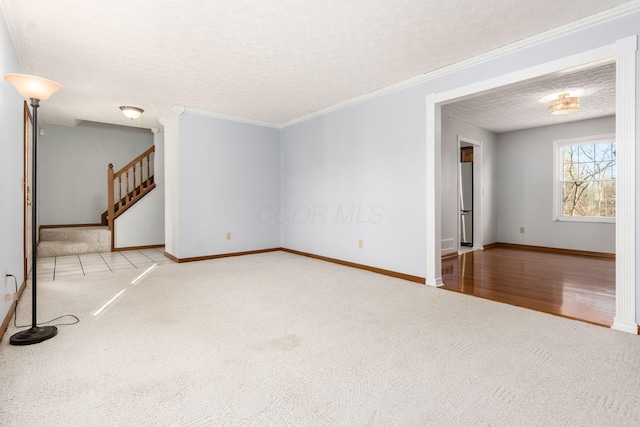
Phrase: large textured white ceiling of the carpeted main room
[{"left": 0, "top": 0, "right": 629, "bottom": 128}]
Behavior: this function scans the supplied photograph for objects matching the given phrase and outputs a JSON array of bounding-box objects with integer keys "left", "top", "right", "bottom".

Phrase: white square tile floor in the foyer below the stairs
[{"left": 36, "top": 248, "right": 173, "bottom": 281}]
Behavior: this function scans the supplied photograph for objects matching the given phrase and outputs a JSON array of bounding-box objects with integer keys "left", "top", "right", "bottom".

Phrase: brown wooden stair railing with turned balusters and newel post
[{"left": 103, "top": 146, "right": 156, "bottom": 236}]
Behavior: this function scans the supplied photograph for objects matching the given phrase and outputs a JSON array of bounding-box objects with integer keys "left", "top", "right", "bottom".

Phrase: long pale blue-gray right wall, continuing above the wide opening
[{"left": 281, "top": 13, "right": 640, "bottom": 284}]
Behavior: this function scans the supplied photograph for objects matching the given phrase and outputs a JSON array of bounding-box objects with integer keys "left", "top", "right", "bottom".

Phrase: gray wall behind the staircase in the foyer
[{"left": 38, "top": 122, "right": 153, "bottom": 225}]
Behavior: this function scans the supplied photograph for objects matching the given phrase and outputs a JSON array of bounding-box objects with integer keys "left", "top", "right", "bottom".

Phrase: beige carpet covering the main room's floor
[{"left": 0, "top": 252, "right": 640, "bottom": 426}]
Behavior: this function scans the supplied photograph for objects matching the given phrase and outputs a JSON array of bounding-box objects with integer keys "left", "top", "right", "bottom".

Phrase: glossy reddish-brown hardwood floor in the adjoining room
[{"left": 442, "top": 247, "right": 615, "bottom": 327}]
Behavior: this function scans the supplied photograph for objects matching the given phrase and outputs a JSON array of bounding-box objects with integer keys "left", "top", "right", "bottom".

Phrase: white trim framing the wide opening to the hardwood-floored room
[{"left": 425, "top": 35, "right": 638, "bottom": 334}]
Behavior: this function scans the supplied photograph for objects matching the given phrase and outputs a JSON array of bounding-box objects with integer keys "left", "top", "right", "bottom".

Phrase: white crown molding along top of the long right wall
[{"left": 279, "top": 0, "right": 640, "bottom": 129}]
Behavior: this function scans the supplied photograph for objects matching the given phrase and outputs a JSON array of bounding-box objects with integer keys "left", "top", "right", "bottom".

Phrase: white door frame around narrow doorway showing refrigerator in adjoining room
[{"left": 457, "top": 135, "right": 484, "bottom": 254}]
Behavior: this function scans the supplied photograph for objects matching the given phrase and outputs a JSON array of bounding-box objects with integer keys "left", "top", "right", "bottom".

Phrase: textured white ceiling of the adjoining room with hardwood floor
[{"left": 442, "top": 63, "right": 616, "bottom": 133}]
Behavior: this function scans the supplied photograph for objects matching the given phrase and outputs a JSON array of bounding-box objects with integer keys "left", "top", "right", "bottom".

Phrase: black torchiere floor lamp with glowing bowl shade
[{"left": 4, "top": 74, "right": 62, "bottom": 345}]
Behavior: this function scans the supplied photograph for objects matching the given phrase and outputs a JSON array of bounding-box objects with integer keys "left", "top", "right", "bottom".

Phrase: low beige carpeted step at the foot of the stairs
[{"left": 38, "top": 226, "right": 111, "bottom": 257}]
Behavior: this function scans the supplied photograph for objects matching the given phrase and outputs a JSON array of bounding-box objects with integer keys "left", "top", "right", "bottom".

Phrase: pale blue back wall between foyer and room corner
[{"left": 170, "top": 113, "right": 280, "bottom": 258}]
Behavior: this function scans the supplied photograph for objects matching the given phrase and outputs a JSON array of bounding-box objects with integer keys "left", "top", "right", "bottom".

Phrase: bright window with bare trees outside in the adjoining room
[{"left": 554, "top": 134, "right": 616, "bottom": 222}]
